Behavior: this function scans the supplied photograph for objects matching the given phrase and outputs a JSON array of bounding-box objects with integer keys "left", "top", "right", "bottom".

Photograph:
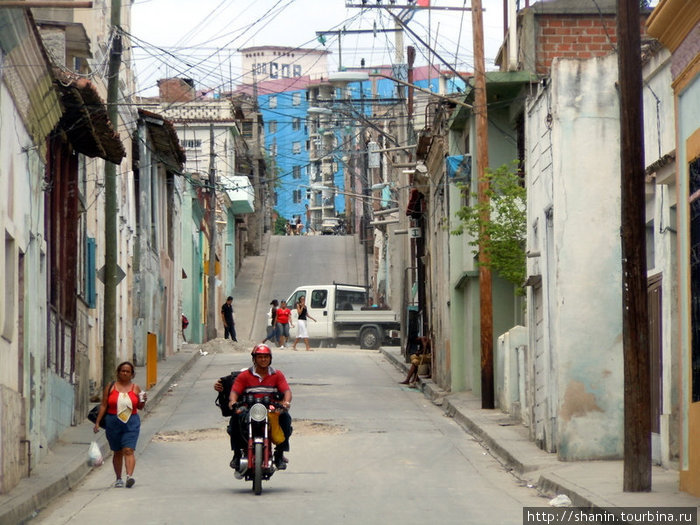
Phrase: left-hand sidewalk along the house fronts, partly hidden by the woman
[{"left": 0, "top": 345, "right": 199, "bottom": 525}]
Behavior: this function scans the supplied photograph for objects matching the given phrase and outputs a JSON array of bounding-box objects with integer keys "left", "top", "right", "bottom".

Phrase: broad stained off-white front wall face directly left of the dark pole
[{"left": 547, "top": 51, "right": 623, "bottom": 460}]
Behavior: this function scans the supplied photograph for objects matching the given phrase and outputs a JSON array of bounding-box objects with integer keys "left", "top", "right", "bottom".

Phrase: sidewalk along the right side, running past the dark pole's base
[{"left": 381, "top": 348, "right": 700, "bottom": 508}]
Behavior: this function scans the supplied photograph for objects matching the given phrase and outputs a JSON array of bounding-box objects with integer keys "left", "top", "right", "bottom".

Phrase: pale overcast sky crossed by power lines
[{"left": 131, "top": 0, "right": 503, "bottom": 96}]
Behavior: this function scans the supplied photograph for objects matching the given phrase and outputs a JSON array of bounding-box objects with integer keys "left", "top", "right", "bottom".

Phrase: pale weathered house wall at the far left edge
[{"left": 0, "top": 81, "right": 48, "bottom": 492}]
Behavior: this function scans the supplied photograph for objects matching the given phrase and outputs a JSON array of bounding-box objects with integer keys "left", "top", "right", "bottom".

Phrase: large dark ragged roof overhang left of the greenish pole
[{"left": 54, "top": 69, "right": 126, "bottom": 164}]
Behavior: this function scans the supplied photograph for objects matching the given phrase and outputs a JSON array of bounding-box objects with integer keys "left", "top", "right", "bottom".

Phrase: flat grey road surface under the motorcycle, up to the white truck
[{"left": 32, "top": 347, "right": 547, "bottom": 525}]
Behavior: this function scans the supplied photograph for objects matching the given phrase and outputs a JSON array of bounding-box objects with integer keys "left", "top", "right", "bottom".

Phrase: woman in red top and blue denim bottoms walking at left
[{"left": 93, "top": 361, "right": 147, "bottom": 489}]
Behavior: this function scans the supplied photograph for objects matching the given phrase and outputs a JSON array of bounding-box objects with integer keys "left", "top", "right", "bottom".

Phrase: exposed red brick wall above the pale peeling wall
[{"left": 536, "top": 15, "right": 646, "bottom": 75}]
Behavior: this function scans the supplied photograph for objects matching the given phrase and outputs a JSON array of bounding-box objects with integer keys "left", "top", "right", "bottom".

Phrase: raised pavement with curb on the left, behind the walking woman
[{"left": 0, "top": 351, "right": 199, "bottom": 525}]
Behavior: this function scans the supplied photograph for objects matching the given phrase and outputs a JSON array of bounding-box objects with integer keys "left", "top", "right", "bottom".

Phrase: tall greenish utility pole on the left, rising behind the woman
[{"left": 102, "top": 0, "right": 122, "bottom": 386}]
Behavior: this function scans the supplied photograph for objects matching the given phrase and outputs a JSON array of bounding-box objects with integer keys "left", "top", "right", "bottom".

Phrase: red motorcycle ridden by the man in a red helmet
[{"left": 234, "top": 394, "right": 284, "bottom": 496}]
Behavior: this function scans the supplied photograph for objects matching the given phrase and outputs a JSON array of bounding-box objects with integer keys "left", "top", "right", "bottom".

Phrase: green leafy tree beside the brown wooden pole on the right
[{"left": 451, "top": 163, "right": 527, "bottom": 295}]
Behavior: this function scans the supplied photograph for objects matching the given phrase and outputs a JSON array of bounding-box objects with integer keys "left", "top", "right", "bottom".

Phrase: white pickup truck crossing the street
[{"left": 287, "top": 283, "right": 401, "bottom": 349}]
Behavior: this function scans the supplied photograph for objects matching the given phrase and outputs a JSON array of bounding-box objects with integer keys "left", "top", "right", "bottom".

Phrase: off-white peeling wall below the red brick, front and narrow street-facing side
[{"left": 525, "top": 55, "right": 623, "bottom": 460}]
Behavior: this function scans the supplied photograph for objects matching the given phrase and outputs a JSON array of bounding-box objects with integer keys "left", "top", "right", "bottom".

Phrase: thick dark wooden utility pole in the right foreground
[{"left": 617, "top": 0, "right": 651, "bottom": 492}]
